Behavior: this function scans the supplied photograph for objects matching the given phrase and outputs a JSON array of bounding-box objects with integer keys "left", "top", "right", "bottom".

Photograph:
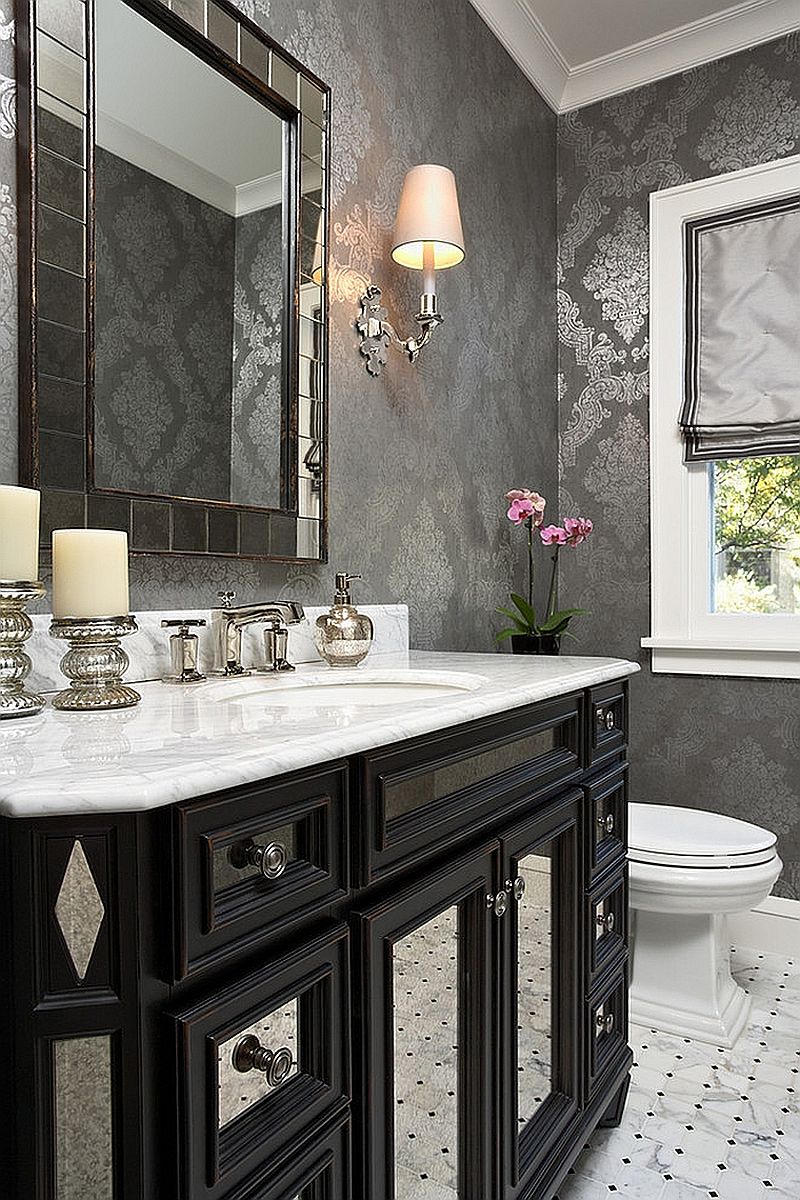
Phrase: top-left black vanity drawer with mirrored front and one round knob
[{"left": 174, "top": 767, "right": 348, "bottom": 979}]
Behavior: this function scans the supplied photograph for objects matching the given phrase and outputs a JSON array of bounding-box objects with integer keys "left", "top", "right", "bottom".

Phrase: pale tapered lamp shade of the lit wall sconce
[{"left": 392, "top": 163, "right": 464, "bottom": 271}]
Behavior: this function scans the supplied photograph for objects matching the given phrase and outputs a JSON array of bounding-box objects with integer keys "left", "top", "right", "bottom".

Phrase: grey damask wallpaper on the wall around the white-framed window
[{"left": 558, "top": 32, "right": 800, "bottom": 898}]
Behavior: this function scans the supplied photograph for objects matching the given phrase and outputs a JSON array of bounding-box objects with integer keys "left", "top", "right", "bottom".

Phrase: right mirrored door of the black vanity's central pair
[{"left": 500, "top": 792, "right": 582, "bottom": 1200}]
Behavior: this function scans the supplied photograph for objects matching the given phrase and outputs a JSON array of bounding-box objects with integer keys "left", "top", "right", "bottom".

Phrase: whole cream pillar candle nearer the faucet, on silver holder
[{"left": 53, "top": 529, "right": 130, "bottom": 617}]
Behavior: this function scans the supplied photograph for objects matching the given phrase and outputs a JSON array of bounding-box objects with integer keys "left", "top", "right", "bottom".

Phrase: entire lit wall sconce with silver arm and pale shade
[{"left": 355, "top": 163, "right": 464, "bottom": 376}]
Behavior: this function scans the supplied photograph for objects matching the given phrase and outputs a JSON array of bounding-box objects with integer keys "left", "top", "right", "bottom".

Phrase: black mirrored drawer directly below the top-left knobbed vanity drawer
[{"left": 175, "top": 926, "right": 349, "bottom": 1200}]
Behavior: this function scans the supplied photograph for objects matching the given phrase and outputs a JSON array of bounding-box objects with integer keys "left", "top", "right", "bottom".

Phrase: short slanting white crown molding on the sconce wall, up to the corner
[{"left": 470, "top": 0, "right": 570, "bottom": 113}]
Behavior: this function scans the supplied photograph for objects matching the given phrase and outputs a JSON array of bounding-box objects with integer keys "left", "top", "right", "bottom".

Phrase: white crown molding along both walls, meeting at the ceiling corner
[{"left": 470, "top": 0, "right": 800, "bottom": 113}]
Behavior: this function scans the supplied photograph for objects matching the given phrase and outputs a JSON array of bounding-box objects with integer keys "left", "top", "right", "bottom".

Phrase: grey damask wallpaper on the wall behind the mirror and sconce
[{"left": 0, "top": 0, "right": 558, "bottom": 650}]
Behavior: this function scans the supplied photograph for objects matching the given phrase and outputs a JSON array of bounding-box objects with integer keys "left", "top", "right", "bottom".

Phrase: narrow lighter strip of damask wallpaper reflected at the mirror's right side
[{"left": 230, "top": 204, "right": 284, "bottom": 509}]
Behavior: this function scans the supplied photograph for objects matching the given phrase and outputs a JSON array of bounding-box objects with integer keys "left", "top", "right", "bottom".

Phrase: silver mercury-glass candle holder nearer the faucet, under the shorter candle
[{"left": 50, "top": 617, "right": 142, "bottom": 713}]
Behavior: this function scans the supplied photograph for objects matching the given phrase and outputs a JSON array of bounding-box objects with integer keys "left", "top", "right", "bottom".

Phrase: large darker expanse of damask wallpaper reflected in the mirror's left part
[{"left": 95, "top": 146, "right": 236, "bottom": 500}]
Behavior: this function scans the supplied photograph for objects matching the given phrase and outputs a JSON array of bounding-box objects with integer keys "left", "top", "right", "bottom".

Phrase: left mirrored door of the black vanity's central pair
[{"left": 355, "top": 842, "right": 498, "bottom": 1200}]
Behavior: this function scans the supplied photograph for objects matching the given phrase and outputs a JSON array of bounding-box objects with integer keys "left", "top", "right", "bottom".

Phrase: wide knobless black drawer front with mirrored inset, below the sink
[{"left": 354, "top": 694, "right": 583, "bottom": 887}]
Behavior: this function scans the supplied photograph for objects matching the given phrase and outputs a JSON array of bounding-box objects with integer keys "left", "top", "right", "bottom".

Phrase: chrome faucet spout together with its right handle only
[{"left": 211, "top": 592, "right": 305, "bottom": 676}]
